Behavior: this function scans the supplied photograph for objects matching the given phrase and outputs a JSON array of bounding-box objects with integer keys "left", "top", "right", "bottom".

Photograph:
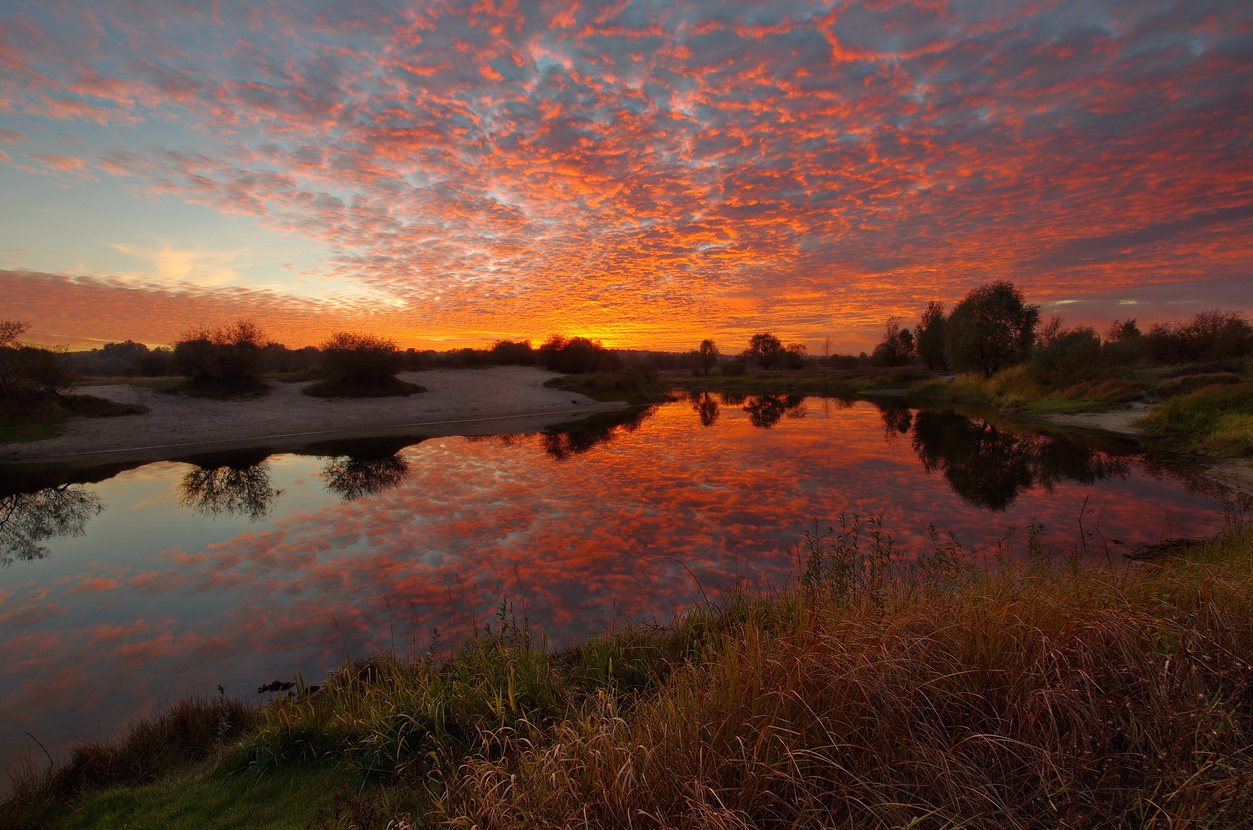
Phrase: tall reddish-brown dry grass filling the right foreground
[{"left": 439, "top": 537, "right": 1253, "bottom": 827}]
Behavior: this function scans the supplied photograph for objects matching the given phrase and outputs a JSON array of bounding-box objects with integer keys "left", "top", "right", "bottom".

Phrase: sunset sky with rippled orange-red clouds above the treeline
[{"left": 0, "top": 0, "right": 1253, "bottom": 354}]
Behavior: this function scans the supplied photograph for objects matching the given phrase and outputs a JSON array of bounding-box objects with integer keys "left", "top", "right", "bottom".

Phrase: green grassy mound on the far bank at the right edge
[{"left": 1136, "top": 382, "right": 1253, "bottom": 458}]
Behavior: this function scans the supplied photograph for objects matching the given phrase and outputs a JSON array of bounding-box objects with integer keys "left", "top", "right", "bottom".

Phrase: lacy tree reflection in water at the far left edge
[{"left": 0, "top": 484, "right": 104, "bottom": 565}]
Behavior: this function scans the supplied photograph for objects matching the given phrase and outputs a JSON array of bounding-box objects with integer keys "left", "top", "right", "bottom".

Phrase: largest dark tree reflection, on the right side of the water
[{"left": 902, "top": 409, "right": 1130, "bottom": 512}]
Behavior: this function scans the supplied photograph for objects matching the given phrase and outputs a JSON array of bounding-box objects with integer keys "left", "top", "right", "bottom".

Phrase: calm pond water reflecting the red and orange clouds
[{"left": 0, "top": 395, "right": 1222, "bottom": 782}]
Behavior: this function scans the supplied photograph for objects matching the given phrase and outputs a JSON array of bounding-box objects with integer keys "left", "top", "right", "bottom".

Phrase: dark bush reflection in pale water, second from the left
[{"left": 178, "top": 450, "right": 283, "bottom": 522}]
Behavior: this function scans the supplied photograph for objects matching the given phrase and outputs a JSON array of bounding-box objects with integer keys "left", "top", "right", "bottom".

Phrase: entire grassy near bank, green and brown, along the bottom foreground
[{"left": 0, "top": 519, "right": 1253, "bottom": 829}]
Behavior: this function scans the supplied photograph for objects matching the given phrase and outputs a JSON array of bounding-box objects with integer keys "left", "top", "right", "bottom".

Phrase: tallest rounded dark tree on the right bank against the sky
[{"left": 945, "top": 280, "right": 1040, "bottom": 377}]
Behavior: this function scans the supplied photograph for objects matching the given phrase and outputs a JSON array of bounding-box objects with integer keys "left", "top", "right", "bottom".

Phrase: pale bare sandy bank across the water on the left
[{"left": 0, "top": 366, "right": 625, "bottom": 464}]
